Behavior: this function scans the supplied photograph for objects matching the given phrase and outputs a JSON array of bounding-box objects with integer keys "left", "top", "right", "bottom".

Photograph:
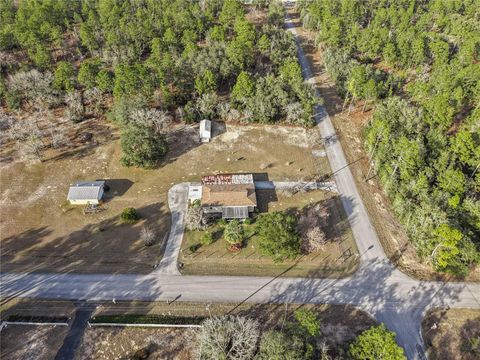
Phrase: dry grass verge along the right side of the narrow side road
[{"left": 290, "top": 5, "right": 480, "bottom": 281}]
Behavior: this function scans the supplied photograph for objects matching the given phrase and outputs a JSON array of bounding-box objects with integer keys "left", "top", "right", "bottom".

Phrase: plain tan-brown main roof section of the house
[{"left": 202, "top": 184, "right": 257, "bottom": 206}]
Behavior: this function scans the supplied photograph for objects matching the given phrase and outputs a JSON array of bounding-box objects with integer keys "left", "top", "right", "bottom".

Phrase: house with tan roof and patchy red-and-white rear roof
[{"left": 201, "top": 174, "right": 257, "bottom": 219}]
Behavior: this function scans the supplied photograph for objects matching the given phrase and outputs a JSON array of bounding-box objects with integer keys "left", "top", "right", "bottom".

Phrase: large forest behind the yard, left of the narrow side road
[{"left": 0, "top": 0, "right": 314, "bottom": 168}]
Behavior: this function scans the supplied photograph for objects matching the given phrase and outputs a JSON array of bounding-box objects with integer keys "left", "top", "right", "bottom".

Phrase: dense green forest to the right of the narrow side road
[{"left": 300, "top": 0, "right": 480, "bottom": 275}]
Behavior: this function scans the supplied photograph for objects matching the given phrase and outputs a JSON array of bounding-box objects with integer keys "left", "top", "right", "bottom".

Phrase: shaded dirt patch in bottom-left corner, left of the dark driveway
[{"left": 0, "top": 325, "right": 68, "bottom": 360}]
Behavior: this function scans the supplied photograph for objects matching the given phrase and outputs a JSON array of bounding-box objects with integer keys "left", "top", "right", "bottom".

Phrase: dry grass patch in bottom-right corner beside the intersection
[{"left": 422, "top": 309, "right": 480, "bottom": 360}]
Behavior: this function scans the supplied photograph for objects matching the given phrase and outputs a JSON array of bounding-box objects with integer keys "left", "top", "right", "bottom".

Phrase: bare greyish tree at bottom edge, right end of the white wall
[{"left": 196, "top": 315, "right": 260, "bottom": 360}]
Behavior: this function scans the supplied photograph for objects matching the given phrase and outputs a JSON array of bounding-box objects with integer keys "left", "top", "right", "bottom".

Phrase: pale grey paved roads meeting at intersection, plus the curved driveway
[{"left": 0, "top": 5, "right": 480, "bottom": 359}]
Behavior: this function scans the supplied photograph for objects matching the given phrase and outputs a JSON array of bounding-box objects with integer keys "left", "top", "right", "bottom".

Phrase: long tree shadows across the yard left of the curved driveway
[{"left": 0, "top": 203, "right": 170, "bottom": 274}]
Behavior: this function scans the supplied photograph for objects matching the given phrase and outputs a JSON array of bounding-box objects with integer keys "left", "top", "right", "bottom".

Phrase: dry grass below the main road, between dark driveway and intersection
[{"left": 77, "top": 302, "right": 376, "bottom": 359}]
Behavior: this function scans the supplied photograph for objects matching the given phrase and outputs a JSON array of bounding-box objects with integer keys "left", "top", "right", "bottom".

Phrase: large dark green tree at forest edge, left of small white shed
[{"left": 120, "top": 124, "right": 168, "bottom": 169}]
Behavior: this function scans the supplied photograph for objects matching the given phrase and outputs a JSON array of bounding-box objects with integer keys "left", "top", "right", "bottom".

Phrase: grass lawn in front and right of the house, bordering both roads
[{"left": 179, "top": 191, "right": 358, "bottom": 277}]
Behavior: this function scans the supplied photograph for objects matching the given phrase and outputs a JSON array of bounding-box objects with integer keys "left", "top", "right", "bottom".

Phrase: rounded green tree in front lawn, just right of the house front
[{"left": 255, "top": 211, "right": 300, "bottom": 262}]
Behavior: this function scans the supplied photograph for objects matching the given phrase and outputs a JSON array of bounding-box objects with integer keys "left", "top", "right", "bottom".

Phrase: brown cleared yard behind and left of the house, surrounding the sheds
[{"left": 0, "top": 123, "right": 329, "bottom": 273}]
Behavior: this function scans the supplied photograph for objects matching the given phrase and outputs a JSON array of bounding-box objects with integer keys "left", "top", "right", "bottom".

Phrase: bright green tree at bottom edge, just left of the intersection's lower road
[{"left": 349, "top": 324, "right": 406, "bottom": 360}]
